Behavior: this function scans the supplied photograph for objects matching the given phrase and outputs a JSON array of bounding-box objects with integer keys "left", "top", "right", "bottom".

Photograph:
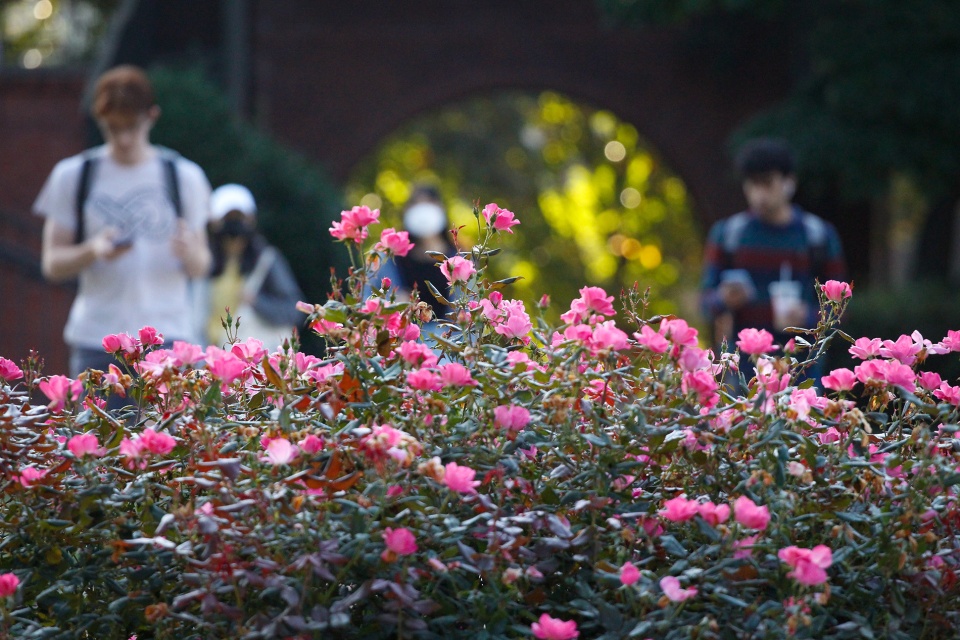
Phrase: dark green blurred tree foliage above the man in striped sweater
[{"left": 598, "top": 0, "right": 960, "bottom": 200}]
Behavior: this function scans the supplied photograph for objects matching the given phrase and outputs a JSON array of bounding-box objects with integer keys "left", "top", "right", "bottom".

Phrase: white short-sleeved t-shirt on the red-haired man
[{"left": 33, "top": 146, "right": 210, "bottom": 349}]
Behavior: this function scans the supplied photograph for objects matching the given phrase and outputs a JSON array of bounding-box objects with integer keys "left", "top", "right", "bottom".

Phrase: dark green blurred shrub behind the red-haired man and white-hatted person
[{"left": 151, "top": 68, "right": 346, "bottom": 351}]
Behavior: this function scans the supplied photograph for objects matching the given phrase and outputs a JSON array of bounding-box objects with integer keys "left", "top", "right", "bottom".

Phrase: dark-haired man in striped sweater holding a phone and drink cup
[{"left": 702, "top": 138, "right": 846, "bottom": 373}]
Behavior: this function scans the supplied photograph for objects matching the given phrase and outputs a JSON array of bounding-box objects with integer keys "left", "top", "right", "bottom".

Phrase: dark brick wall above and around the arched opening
[{"left": 251, "top": 0, "right": 789, "bottom": 223}]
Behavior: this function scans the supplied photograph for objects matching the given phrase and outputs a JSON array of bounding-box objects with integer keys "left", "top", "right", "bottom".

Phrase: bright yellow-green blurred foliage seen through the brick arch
[{"left": 347, "top": 92, "right": 701, "bottom": 322}]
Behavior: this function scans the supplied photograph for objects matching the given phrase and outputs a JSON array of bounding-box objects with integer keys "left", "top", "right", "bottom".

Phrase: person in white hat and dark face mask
[{"left": 206, "top": 184, "right": 303, "bottom": 349}]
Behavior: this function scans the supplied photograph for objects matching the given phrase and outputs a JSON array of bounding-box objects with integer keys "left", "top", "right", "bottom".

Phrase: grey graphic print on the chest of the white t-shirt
[{"left": 87, "top": 187, "right": 176, "bottom": 243}]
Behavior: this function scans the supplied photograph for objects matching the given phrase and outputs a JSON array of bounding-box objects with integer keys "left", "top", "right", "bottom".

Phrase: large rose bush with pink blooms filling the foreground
[{"left": 0, "top": 205, "right": 960, "bottom": 639}]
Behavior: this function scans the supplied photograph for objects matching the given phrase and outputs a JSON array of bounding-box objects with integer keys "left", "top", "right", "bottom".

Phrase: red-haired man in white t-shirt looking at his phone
[{"left": 34, "top": 66, "right": 210, "bottom": 376}]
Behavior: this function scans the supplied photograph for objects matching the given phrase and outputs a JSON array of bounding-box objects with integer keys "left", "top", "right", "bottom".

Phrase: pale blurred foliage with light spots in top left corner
[{"left": 0, "top": 0, "right": 120, "bottom": 69}]
